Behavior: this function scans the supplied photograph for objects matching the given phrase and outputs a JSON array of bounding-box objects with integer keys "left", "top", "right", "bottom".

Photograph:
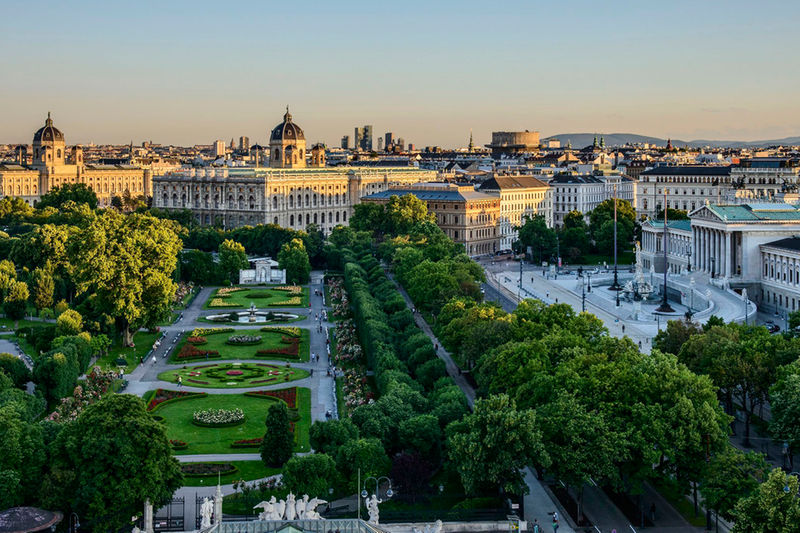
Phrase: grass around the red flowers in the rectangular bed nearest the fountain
[{"left": 168, "top": 325, "right": 309, "bottom": 364}]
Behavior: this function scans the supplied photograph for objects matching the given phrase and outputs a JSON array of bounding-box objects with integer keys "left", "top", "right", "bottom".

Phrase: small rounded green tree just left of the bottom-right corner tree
[{"left": 700, "top": 446, "right": 769, "bottom": 520}]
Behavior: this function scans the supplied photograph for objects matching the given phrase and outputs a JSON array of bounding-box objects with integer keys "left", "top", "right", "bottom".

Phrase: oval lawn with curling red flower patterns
[{"left": 158, "top": 363, "right": 308, "bottom": 389}]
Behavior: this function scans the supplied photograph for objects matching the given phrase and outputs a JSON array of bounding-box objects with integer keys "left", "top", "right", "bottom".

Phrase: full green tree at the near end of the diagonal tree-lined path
[{"left": 447, "top": 394, "right": 550, "bottom": 494}]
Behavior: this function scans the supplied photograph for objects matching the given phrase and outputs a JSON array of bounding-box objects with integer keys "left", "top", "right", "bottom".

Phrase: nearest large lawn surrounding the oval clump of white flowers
[{"left": 152, "top": 388, "right": 311, "bottom": 455}]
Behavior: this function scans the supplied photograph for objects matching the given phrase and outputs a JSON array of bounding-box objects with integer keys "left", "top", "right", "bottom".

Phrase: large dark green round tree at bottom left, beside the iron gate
[{"left": 41, "top": 394, "right": 183, "bottom": 532}]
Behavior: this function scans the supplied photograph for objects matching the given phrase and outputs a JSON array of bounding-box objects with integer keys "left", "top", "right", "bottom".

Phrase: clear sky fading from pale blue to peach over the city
[{"left": 0, "top": 0, "right": 800, "bottom": 146}]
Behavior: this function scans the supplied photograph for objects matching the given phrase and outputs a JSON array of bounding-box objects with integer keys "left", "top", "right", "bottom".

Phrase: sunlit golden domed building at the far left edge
[{"left": 0, "top": 113, "right": 152, "bottom": 206}]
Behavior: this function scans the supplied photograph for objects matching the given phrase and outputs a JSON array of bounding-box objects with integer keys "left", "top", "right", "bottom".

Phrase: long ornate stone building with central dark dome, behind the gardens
[{"left": 153, "top": 109, "right": 436, "bottom": 233}]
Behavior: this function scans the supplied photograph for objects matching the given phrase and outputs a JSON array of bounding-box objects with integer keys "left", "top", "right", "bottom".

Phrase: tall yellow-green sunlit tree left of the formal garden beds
[{"left": 70, "top": 209, "right": 181, "bottom": 346}]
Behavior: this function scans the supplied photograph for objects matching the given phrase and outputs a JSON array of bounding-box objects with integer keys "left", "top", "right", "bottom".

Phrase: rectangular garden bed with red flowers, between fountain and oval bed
[{"left": 169, "top": 327, "right": 309, "bottom": 364}]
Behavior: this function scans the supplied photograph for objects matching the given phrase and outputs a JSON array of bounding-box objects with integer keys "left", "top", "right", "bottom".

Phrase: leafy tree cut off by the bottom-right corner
[{"left": 732, "top": 468, "right": 800, "bottom": 533}]
